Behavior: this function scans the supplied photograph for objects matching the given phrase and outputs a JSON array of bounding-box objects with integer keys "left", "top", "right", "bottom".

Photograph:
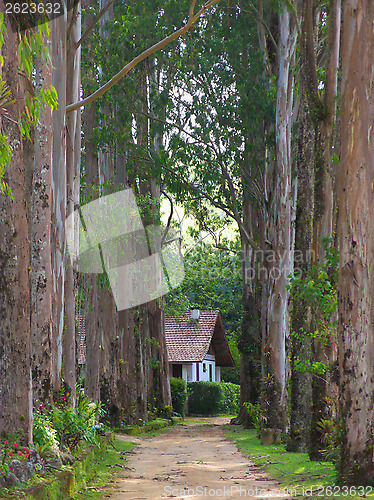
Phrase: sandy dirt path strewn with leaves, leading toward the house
[{"left": 111, "top": 418, "right": 292, "bottom": 500}]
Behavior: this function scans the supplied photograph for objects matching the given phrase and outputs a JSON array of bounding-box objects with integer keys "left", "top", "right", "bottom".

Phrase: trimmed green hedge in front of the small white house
[{"left": 188, "top": 382, "right": 240, "bottom": 415}]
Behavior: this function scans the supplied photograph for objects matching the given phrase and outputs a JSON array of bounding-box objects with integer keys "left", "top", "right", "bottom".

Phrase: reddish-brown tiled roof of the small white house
[{"left": 165, "top": 311, "right": 235, "bottom": 366}]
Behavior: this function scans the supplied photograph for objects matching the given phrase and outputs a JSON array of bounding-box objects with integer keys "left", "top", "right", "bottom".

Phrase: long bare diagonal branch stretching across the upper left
[{"left": 66, "top": 0, "right": 220, "bottom": 113}]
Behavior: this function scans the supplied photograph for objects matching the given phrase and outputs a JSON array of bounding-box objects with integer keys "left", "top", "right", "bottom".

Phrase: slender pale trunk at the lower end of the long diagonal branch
[{"left": 63, "top": 2, "right": 81, "bottom": 406}]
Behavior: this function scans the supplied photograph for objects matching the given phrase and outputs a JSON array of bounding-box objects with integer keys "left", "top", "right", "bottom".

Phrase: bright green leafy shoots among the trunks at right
[{"left": 287, "top": 238, "right": 339, "bottom": 374}]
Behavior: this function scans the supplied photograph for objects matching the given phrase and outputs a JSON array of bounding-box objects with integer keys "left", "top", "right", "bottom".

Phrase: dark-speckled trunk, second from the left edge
[{"left": 30, "top": 35, "right": 54, "bottom": 405}]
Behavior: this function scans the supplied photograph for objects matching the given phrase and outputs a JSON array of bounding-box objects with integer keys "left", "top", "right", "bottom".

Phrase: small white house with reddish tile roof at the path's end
[{"left": 165, "top": 309, "right": 235, "bottom": 382}]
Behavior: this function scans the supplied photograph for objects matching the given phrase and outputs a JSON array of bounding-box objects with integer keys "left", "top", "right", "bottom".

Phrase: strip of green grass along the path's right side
[{"left": 226, "top": 426, "right": 374, "bottom": 500}]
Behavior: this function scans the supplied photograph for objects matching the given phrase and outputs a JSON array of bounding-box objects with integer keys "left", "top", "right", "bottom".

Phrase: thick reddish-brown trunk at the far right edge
[{"left": 338, "top": 0, "right": 374, "bottom": 485}]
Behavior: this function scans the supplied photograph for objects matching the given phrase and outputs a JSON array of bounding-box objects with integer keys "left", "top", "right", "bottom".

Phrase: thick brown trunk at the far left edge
[{"left": 0, "top": 17, "right": 33, "bottom": 445}]
